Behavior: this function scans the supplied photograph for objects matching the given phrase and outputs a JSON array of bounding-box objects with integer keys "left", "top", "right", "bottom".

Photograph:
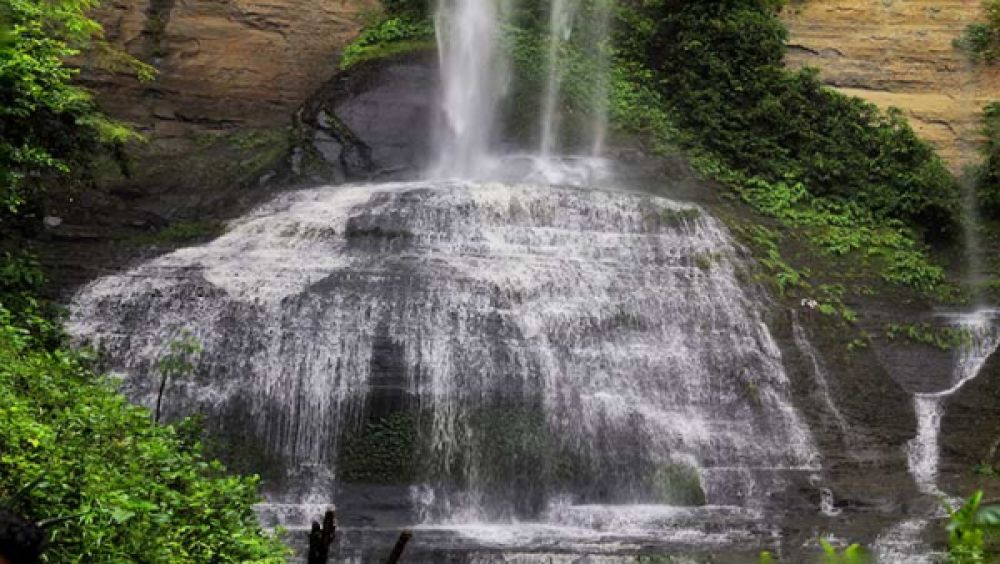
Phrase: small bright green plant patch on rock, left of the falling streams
[{"left": 340, "top": 13, "right": 434, "bottom": 70}]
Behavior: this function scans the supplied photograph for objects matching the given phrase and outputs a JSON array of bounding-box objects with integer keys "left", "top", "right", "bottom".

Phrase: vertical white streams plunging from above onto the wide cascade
[{"left": 429, "top": 0, "right": 612, "bottom": 176}]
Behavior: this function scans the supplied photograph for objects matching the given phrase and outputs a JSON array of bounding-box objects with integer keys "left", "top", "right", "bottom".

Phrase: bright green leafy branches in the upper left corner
[{"left": 0, "top": 0, "right": 152, "bottom": 224}]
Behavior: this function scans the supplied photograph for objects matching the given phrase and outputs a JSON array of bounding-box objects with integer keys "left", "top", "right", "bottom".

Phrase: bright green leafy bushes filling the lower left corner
[{"left": 0, "top": 309, "right": 286, "bottom": 563}]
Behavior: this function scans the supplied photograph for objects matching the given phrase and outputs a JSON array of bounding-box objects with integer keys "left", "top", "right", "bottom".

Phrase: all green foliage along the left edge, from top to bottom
[{"left": 0, "top": 0, "right": 286, "bottom": 562}]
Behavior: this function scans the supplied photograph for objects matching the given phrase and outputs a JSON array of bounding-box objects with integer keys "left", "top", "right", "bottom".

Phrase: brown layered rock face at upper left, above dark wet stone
[{"left": 83, "top": 0, "right": 380, "bottom": 140}]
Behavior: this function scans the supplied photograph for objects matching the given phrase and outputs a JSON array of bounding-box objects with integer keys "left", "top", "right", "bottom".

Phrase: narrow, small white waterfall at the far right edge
[{"left": 906, "top": 310, "right": 1000, "bottom": 495}]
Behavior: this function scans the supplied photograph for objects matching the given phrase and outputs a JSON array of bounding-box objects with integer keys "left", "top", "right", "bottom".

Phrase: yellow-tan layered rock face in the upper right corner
[{"left": 784, "top": 0, "right": 1000, "bottom": 170}]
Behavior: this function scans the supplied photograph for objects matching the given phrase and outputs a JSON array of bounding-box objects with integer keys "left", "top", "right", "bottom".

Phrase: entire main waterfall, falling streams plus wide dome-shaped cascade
[{"left": 69, "top": 0, "right": 819, "bottom": 556}]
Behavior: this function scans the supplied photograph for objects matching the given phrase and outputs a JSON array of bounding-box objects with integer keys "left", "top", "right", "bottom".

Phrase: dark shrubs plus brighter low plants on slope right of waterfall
[{"left": 596, "top": 0, "right": 961, "bottom": 321}]
